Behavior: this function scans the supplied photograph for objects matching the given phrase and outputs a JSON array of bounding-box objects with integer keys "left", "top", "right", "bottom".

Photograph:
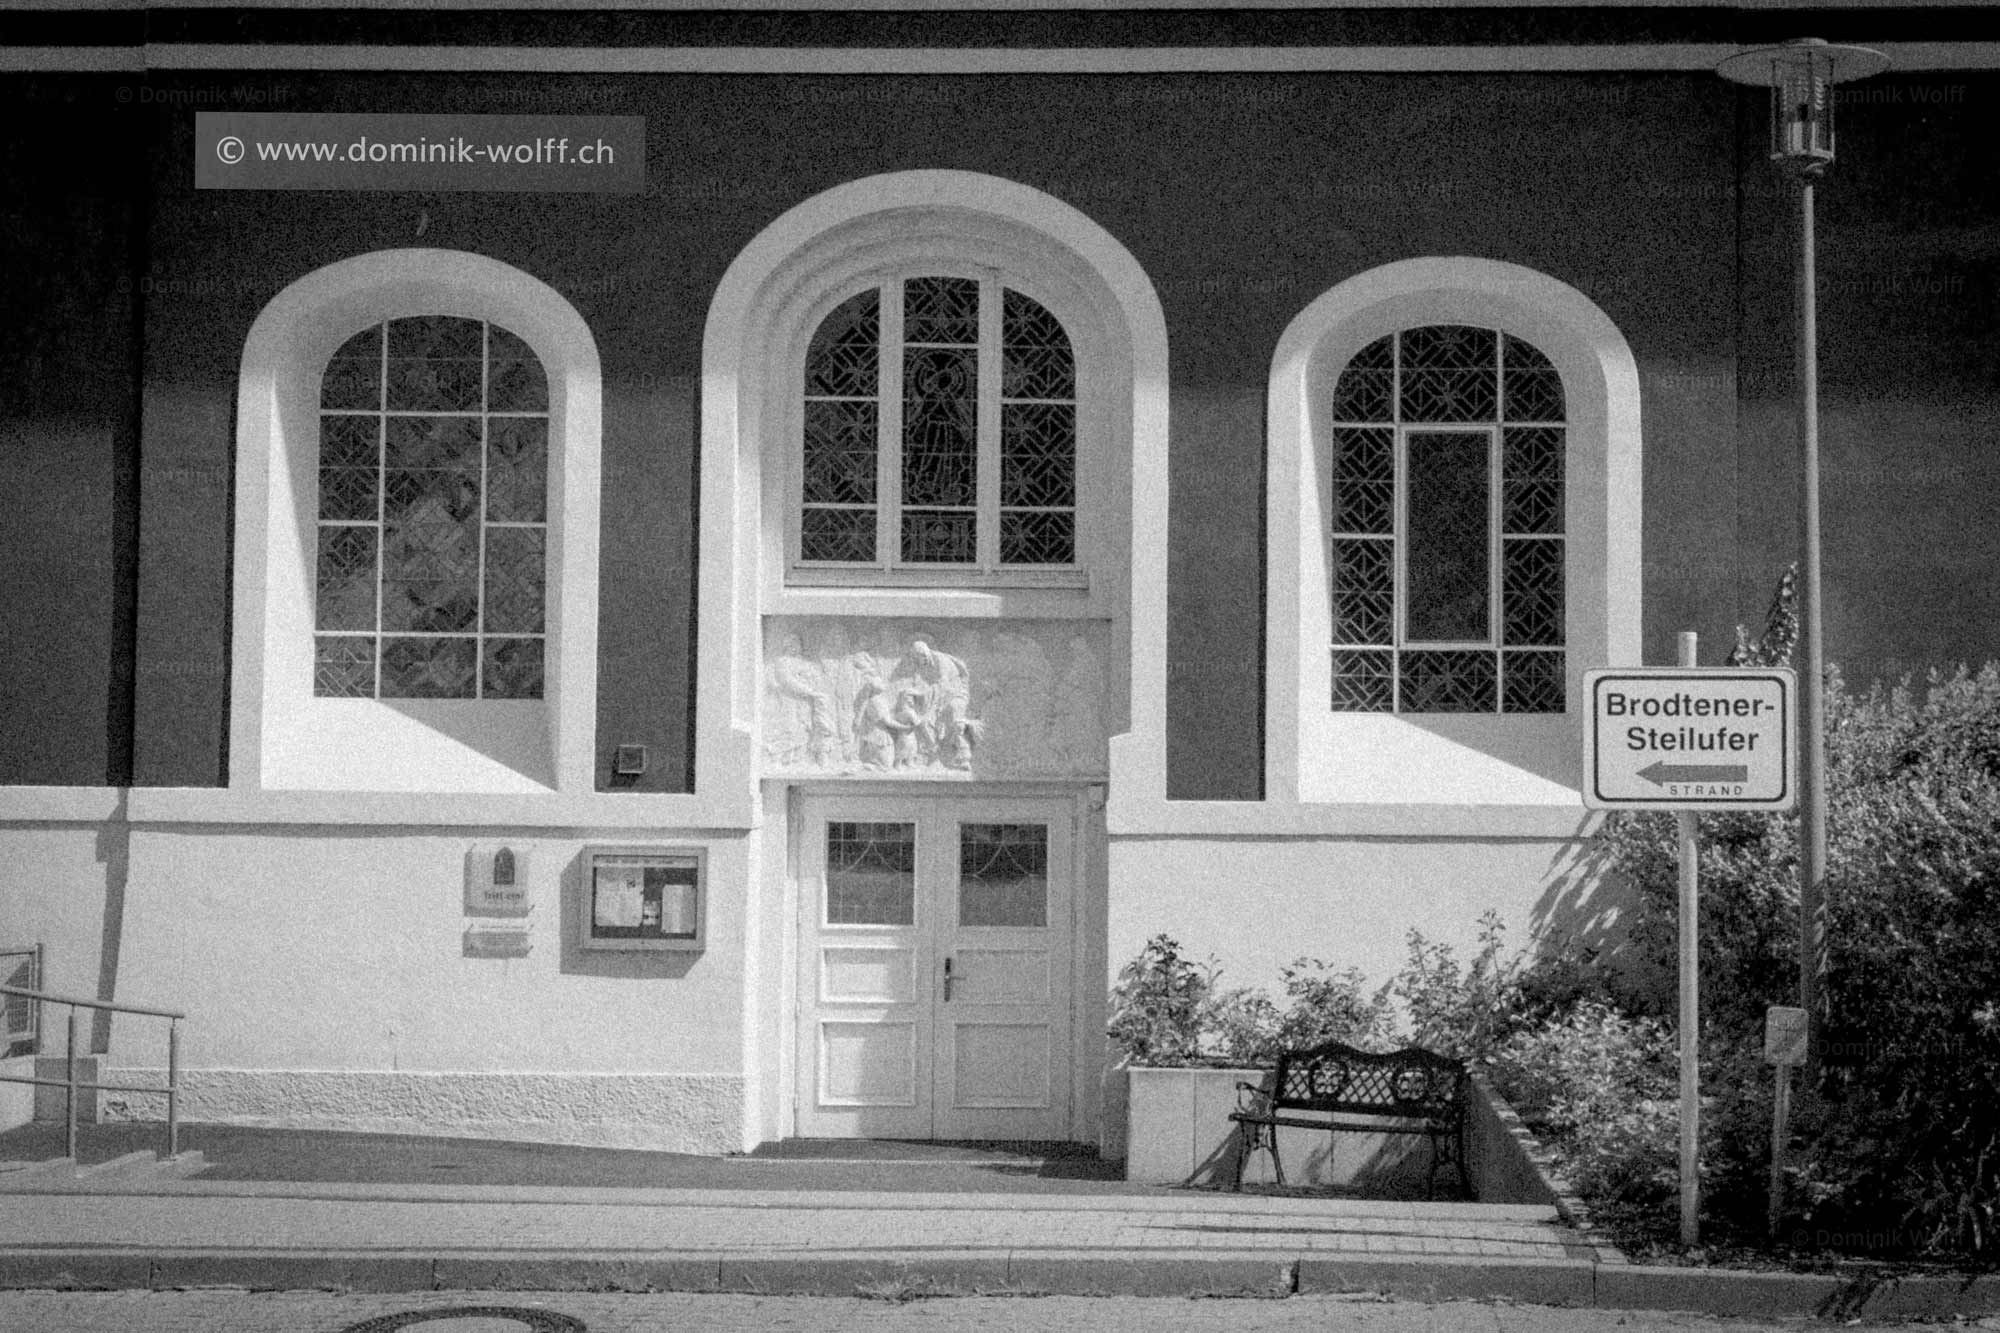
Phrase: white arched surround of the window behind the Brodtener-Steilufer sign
[{"left": 1264, "top": 258, "right": 1642, "bottom": 807}]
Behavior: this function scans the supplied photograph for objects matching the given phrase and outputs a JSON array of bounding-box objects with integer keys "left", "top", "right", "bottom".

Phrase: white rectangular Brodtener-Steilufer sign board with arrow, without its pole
[{"left": 1584, "top": 667, "right": 1798, "bottom": 811}]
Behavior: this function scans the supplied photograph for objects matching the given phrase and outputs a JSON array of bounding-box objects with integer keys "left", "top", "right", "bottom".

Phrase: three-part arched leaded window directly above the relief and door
[{"left": 798, "top": 276, "right": 1076, "bottom": 572}]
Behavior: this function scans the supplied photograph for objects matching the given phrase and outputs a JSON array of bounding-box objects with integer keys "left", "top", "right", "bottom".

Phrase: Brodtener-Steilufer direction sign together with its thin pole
[{"left": 1584, "top": 644, "right": 1798, "bottom": 1245}]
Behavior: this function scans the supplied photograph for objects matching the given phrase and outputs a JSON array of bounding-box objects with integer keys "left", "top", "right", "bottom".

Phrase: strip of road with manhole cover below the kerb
[{"left": 0, "top": 1289, "right": 1976, "bottom": 1333}]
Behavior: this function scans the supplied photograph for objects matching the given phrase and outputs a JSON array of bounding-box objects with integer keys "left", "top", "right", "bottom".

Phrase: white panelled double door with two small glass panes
[{"left": 798, "top": 797, "right": 1074, "bottom": 1139}]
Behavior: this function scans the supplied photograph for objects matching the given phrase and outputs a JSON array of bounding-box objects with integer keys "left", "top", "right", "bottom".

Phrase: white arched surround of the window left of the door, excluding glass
[{"left": 230, "top": 248, "right": 602, "bottom": 793}]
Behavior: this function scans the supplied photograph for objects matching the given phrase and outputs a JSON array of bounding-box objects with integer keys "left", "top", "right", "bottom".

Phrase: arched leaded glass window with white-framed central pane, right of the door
[{"left": 1330, "top": 324, "right": 1566, "bottom": 713}]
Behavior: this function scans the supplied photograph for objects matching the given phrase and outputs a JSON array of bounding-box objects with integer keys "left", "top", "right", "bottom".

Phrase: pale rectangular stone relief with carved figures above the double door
[{"left": 762, "top": 616, "right": 1106, "bottom": 779}]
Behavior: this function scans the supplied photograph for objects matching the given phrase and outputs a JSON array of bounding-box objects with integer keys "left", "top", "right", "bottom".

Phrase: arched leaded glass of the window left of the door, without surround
[{"left": 314, "top": 314, "right": 548, "bottom": 699}]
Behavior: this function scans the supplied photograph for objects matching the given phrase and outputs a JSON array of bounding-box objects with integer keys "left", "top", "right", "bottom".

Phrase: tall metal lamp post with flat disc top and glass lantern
[{"left": 1716, "top": 38, "right": 1888, "bottom": 1087}]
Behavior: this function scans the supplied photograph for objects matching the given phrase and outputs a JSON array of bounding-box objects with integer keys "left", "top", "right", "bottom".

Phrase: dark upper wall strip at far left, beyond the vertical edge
[{"left": 0, "top": 76, "right": 140, "bottom": 787}]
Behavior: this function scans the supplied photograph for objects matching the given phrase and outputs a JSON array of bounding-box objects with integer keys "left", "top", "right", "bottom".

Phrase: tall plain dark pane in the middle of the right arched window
[{"left": 1404, "top": 432, "right": 1492, "bottom": 642}]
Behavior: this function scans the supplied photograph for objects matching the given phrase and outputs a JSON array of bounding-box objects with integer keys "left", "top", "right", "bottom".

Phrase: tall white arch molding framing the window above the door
[{"left": 696, "top": 170, "right": 1166, "bottom": 803}]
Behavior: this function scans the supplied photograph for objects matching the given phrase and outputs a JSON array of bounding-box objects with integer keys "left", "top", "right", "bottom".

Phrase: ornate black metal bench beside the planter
[{"left": 1230, "top": 1041, "right": 1472, "bottom": 1195}]
